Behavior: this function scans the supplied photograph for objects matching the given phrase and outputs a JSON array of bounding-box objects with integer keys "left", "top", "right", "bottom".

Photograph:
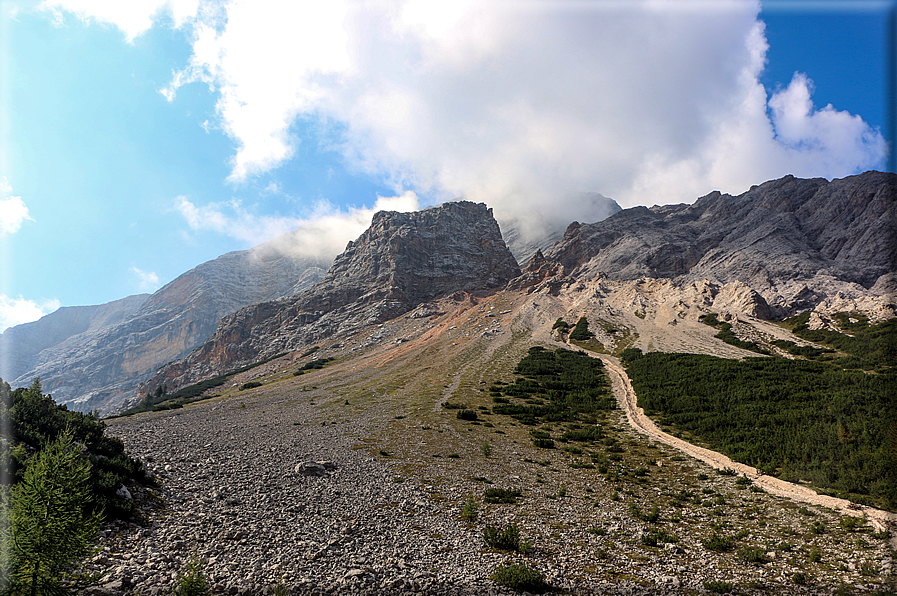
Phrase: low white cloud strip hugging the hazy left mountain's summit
[{"left": 175, "top": 191, "right": 419, "bottom": 260}]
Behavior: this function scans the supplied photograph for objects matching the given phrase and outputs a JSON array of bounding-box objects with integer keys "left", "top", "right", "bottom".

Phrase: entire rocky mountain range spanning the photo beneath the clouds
[{"left": 0, "top": 172, "right": 897, "bottom": 412}]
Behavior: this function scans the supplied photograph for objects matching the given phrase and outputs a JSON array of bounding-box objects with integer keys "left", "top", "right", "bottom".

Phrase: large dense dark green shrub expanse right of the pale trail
[{"left": 624, "top": 340, "right": 897, "bottom": 508}]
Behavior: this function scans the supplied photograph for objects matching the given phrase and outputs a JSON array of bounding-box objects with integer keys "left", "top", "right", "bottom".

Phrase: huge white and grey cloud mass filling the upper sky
[{"left": 47, "top": 0, "right": 887, "bottom": 221}]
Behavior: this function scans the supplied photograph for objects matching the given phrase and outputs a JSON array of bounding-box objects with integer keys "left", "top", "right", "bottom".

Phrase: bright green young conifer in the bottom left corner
[{"left": 3, "top": 430, "right": 102, "bottom": 596}]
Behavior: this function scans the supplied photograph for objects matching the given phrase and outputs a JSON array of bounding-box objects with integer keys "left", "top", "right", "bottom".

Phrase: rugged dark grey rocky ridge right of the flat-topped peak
[{"left": 545, "top": 172, "right": 897, "bottom": 316}]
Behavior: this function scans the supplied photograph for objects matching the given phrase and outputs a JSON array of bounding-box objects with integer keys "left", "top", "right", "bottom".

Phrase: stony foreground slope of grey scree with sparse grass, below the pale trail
[{"left": 83, "top": 358, "right": 893, "bottom": 596}]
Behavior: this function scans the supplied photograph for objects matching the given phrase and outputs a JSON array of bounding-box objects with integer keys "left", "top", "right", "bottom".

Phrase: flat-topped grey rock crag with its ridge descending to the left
[{"left": 148, "top": 201, "right": 520, "bottom": 392}]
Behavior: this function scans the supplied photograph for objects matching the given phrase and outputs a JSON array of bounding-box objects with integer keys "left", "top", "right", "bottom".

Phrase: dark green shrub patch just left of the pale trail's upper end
[{"left": 489, "top": 346, "right": 616, "bottom": 426}]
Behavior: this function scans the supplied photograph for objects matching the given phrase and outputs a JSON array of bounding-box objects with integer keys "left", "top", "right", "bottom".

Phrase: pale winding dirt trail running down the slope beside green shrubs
[{"left": 593, "top": 354, "right": 897, "bottom": 548}]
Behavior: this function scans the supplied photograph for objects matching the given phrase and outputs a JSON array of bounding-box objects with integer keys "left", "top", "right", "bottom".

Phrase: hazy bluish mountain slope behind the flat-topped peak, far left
[{"left": 0, "top": 244, "right": 328, "bottom": 411}]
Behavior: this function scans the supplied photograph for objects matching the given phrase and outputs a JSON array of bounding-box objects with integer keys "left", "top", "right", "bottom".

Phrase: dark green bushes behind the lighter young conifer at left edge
[{"left": 0, "top": 379, "right": 151, "bottom": 518}]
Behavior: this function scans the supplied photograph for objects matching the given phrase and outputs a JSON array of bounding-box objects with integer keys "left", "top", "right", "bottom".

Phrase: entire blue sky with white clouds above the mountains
[{"left": 0, "top": 0, "right": 895, "bottom": 329}]
